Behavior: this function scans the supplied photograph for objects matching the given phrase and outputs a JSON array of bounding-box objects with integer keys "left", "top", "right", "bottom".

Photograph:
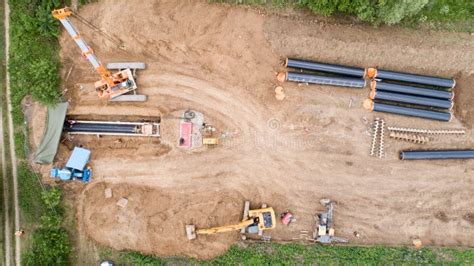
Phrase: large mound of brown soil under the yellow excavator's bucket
[{"left": 82, "top": 182, "right": 244, "bottom": 258}]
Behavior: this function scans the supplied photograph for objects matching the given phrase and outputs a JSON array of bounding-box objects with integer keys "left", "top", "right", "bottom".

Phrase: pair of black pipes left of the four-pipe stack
[{"left": 278, "top": 58, "right": 365, "bottom": 88}]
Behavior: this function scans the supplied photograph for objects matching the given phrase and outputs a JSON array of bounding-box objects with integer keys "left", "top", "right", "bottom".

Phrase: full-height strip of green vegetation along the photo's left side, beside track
[{"left": 9, "top": 0, "right": 69, "bottom": 265}]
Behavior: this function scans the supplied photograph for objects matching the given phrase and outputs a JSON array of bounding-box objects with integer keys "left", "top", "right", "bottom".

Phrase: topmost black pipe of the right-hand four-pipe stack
[{"left": 367, "top": 68, "right": 456, "bottom": 88}]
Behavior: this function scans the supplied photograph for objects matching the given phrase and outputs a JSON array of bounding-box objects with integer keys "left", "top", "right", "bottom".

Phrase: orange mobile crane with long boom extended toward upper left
[{"left": 52, "top": 7, "right": 145, "bottom": 100}]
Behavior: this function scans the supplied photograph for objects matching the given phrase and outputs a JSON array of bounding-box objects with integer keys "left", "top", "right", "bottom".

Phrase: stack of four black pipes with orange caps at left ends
[{"left": 367, "top": 68, "right": 456, "bottom": 121}]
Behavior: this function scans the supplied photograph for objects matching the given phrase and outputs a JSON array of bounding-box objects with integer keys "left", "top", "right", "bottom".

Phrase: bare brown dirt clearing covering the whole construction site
[{"left": 24, "top": 0, "right": 474, "bottom": 263}]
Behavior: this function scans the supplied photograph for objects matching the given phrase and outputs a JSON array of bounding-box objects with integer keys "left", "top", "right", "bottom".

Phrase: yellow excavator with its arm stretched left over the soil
[{"left": 186, "top": 201, "right": 275, "bottom": 240}]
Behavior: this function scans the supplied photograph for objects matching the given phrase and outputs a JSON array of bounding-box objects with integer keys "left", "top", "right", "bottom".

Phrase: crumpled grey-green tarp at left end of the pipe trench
[{"left": 34, "top": 102, "right": 69, "bottom": 164}]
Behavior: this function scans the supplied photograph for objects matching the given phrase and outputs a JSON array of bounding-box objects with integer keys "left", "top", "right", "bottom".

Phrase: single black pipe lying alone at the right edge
[{"left": 400, "top": 150, "right": 474, "bottom": 160}]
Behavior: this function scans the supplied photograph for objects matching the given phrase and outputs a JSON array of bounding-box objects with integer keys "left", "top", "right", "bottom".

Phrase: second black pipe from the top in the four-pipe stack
[{"left": 371, "top": 80, "right": 454, "bottom": 100}]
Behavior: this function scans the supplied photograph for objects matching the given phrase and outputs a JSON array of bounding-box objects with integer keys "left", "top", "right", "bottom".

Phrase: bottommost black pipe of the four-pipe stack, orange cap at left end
[{"left": 364, "top": 100, "right": 452, "bottom": 122}]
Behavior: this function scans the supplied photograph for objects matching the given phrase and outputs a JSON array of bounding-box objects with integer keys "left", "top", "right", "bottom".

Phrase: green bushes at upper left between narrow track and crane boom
[{"left": 9, "top": 0, "right": 62, "bottom": 119}]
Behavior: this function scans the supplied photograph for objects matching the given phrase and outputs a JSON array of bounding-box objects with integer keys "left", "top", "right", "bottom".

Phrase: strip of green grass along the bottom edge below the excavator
[{"left": 115, "top": 244, "right": 474, "bottom": 265}]
